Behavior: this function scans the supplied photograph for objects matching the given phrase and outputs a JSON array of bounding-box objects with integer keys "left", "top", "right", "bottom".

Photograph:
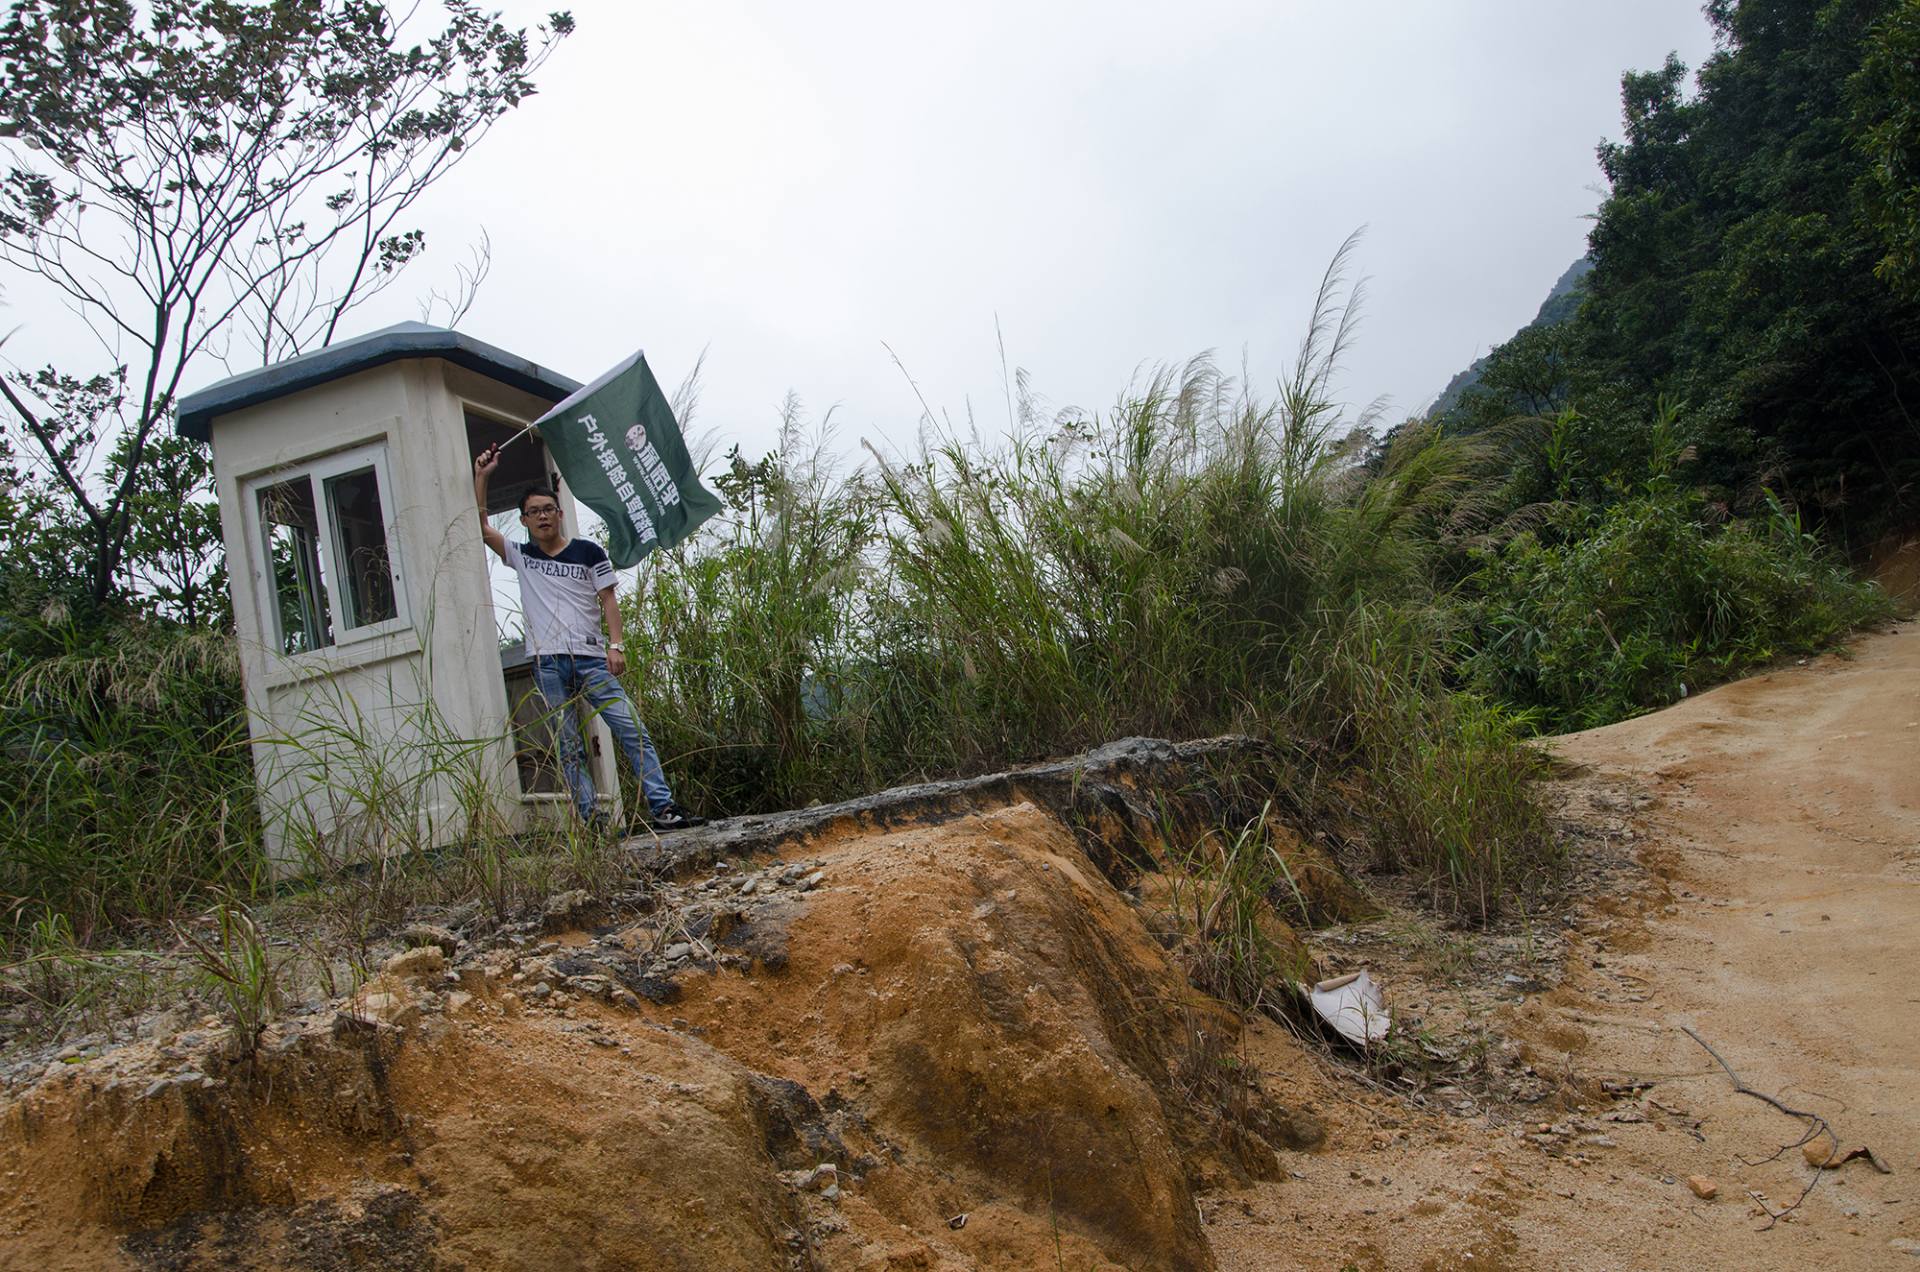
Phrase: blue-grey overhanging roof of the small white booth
[{"left": 173, "top": 323, "right": 580, "bottom": 442}]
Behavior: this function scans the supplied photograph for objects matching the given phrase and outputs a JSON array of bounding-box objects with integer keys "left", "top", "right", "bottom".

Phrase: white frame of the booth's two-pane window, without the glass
[{"left": 242, "top": 438, "right": 413, "bottom": 661}]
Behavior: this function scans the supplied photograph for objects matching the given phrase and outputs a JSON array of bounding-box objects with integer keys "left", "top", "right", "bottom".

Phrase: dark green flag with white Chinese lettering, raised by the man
[{"left": 536, "top": 354, "right": 720, "bottom": 569}]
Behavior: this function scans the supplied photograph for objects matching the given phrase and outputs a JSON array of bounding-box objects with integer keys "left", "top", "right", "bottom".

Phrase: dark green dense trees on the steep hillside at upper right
[{"left": 1571, "top": 0, "right": 1920, "bottom": 542}]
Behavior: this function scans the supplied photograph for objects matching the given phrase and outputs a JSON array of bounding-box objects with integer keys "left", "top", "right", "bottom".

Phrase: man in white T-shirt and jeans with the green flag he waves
[{"left": 474, "top": 354, "right": 720, "bottom": 830}]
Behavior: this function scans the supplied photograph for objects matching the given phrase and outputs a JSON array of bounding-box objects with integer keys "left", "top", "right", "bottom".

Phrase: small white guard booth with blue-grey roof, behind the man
[{"left": 177, "top": 323, "right": 620, "bottom": 874}]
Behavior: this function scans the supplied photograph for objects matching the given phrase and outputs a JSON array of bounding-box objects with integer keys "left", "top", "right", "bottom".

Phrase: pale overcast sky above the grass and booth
[{"left": 10, "top": 0, "right": 1711, "bottom": 470}]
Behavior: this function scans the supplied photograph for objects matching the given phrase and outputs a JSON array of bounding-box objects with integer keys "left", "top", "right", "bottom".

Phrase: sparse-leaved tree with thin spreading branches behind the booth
[{"left": 0, "top": 0, "right": 572, "bottom": 603}]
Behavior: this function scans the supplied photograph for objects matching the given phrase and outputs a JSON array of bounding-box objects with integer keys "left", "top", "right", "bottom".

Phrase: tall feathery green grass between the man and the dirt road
[{"left": 630, "top": 239, "right": 1551, "bottom": 918}]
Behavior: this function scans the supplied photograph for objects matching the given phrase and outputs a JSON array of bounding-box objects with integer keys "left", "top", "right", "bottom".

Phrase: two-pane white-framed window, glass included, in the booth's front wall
[{"left": 253, "top": 446, "right": 403, "bottom": 653}]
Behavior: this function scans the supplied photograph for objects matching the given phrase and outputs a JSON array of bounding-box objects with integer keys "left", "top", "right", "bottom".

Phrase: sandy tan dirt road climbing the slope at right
[{"left": 1202, "top": 623, "right": 1920, "bottom": 1270}]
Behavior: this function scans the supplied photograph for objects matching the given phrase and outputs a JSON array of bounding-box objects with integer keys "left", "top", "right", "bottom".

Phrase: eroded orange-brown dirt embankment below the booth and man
[{"left": 0, "top": 744, "right": 1344, "bottom": 1270}]
